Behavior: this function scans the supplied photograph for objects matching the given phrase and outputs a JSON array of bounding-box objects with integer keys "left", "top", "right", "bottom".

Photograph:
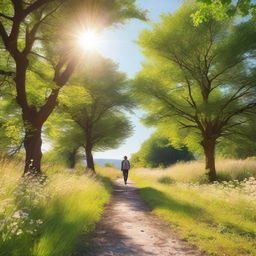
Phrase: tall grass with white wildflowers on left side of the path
[{"left": 0, "top": 160, "right": 120, "bottom": 256}]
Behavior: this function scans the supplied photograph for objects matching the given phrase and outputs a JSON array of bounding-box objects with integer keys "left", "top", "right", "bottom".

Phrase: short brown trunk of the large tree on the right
[{"left": 202, "top": 139, "right": 217, "bottom": 182}]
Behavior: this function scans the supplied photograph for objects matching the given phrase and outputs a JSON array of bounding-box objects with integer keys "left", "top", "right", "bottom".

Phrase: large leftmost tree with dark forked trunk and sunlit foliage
[{"left": 0, "top": 0, "right": 144, "bottom": 174}]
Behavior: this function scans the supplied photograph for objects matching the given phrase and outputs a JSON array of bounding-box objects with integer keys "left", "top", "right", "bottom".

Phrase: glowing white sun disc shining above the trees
[{"left": 77, "top": 29, "right": 100, "bottom": 50}]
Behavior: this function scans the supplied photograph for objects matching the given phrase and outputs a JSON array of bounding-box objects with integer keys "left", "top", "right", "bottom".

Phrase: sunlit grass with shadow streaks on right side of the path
[{"left": 132, "top": 160, "right": 256, "bottom": 256}]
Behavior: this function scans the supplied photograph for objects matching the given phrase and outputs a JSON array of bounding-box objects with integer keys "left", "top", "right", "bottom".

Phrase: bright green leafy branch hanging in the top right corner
[{"left": 192, "top": 0, "right": 256, "bottom": 25}]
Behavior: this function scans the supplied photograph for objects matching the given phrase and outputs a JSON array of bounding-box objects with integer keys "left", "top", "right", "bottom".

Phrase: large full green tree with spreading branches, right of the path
[{"left": 134, "top": 4, "right": 256, "bottom": 181}]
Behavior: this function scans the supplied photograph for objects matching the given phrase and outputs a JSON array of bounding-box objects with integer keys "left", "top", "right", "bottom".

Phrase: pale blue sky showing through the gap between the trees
[{"left": 94, "top": 0, "right": 182, "bottom": 159}]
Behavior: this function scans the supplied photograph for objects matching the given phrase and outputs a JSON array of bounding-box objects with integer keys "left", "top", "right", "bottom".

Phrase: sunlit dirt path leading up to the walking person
[{"left": 80, "top": 179, "right": 204, "bottom": 256}]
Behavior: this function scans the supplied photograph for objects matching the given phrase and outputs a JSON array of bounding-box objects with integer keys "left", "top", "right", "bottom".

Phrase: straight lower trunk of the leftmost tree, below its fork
[{"left": 24, "top": 122, "right": 42, "bottom": 175}]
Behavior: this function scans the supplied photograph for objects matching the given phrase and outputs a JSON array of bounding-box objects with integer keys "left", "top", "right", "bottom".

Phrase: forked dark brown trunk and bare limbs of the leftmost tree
[{"left": 9, "top": 28, "right": 77, "bottom": 175}]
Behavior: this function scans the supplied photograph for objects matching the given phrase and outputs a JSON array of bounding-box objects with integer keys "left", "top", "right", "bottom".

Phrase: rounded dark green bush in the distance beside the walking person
[{"left": 131, "top": 133, "right": 194, "bottom": 168}]
